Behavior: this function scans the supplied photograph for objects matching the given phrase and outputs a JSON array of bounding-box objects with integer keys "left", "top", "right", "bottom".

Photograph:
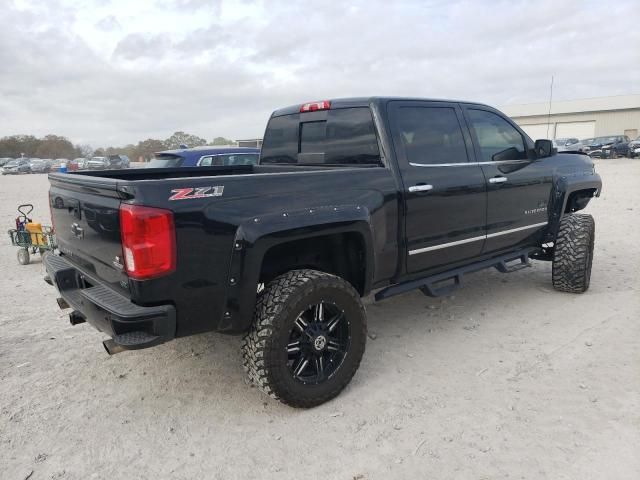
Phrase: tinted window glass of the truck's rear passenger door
[{"left": 395, "top": 107, "right": 467, "bottom": 165}]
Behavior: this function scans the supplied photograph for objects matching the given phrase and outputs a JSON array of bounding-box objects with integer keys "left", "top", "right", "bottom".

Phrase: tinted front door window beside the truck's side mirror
[{"left": 467, "top": 109, "right": 527, "bottom": 162}]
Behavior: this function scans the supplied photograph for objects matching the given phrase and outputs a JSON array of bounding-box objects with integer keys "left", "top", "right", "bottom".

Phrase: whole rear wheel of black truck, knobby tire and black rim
[{"left": 242, "top": 270, "right": 367, "bottom": 408}]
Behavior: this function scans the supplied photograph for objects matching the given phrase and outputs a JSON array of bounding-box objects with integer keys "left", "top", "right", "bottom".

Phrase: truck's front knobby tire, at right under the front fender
[{"left": 551, "top": 214, "right": 596, "bottom": 293}]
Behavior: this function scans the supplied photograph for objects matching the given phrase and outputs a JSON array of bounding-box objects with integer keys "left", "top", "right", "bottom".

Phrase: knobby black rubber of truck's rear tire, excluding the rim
[{"left": 242, "top": 270, "right": 367, "bottom": 408}]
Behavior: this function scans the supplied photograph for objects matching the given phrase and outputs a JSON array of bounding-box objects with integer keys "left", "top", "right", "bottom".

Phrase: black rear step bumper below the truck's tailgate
[{"left": 44, "top": 254, "right": 176, "bottom": 350}]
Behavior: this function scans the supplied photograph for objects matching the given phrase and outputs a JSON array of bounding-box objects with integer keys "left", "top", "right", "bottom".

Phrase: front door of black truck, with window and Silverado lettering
[{"left": 465, "top": 106, "right": 556, "bottom": 253}]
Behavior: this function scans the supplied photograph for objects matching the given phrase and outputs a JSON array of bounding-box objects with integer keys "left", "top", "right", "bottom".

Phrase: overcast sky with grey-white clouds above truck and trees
[{"left": 0, "top": 0, "right": 640, "bottom": 147}]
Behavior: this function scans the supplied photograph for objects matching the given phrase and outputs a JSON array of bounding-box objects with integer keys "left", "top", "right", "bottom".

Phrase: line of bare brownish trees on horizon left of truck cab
[{"left": 0, "top": 132, "right": 234, "bottom": 161}]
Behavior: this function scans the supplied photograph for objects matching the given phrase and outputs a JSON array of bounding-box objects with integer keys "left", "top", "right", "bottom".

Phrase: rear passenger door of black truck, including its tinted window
[{"left": 388, "top": 101, "right": 486, "bottom": 273}]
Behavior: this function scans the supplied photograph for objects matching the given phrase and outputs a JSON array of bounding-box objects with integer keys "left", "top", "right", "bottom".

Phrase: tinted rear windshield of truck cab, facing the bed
[{"left": 260, "top": 107, "right": 380, "bottom": 164}]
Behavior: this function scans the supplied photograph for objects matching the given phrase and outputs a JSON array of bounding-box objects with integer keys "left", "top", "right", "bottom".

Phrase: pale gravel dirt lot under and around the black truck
[{"left": 0, "top": 159, "right": 640, "bottom": 480}]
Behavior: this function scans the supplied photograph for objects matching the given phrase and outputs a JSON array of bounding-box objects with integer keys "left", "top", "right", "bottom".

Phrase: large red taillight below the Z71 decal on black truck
[{"left": 120, "top": 203, "right": 176, "bottom": 280}]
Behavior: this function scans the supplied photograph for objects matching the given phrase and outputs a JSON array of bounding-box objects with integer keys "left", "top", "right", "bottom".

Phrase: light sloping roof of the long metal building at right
[{"left": 500, "top": 94, "right": 640, "bottom": 117}]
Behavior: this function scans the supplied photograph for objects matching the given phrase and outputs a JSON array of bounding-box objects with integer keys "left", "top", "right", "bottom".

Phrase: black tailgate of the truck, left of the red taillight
[{"left": 49, "top": 174, "right": 128, "bottom": 295}]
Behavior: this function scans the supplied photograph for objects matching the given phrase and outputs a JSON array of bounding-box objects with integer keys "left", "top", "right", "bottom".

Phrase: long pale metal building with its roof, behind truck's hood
[{"left": 501, "top": 95, "right": 640, "bottom": 140}]
